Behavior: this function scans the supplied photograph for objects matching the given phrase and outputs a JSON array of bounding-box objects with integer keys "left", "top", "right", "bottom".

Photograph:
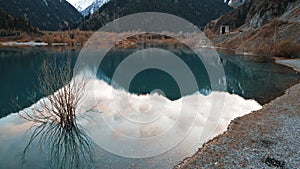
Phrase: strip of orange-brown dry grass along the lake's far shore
[{"left": 0, "top": 29, "right": 300, "bottom": 70}]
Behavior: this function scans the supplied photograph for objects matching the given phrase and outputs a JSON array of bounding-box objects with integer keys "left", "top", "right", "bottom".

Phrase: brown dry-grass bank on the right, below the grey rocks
[{"left": 212, "top": 18, "right": 300, "bottom": 58}]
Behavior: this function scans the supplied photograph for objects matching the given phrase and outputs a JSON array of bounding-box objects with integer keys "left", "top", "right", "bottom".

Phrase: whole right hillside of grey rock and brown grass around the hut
[{"left": 205, "top": 0, "right": 300, "bottom": 57}]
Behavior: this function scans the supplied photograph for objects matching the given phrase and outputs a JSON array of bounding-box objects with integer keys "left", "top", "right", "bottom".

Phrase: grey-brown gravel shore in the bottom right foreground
[{"left": 175, "top": 83, "right": 300, "bottom": 169}]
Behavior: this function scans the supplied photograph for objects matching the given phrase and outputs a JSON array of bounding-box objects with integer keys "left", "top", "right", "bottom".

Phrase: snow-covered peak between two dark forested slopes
[{"left": 67, "top": 0, "right": 109, "bottom": 16}]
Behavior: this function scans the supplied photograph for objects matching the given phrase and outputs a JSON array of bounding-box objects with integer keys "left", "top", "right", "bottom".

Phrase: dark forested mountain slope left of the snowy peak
[{"left": 0, "top": 0, "right": 81, "bottom": 30}]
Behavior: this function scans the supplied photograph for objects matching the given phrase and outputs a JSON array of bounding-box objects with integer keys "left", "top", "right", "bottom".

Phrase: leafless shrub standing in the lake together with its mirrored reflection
[{"left": 19, "top": 59, "right": 94, "bottom": 168}]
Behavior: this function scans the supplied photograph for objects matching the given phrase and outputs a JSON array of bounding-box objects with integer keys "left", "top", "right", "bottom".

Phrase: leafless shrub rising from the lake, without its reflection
[{"left": 20, "top": 59, "right": 86, "bottom": 130}]
